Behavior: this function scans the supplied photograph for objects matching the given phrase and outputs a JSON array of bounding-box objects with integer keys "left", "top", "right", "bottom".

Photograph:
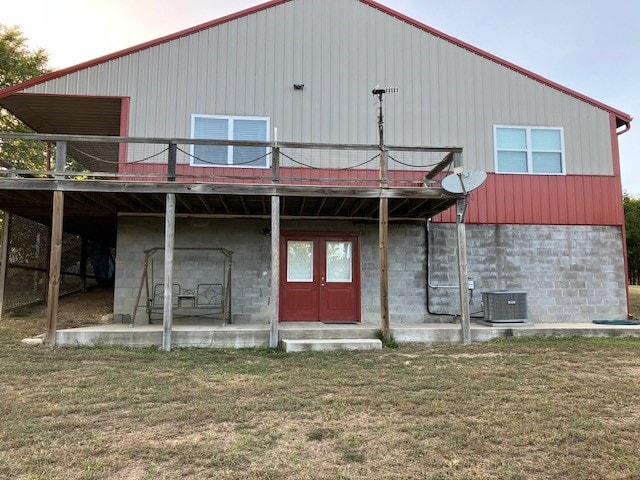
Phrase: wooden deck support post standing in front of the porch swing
[{"left": 162, "top": 193, "right": 176, "bottom": 352}]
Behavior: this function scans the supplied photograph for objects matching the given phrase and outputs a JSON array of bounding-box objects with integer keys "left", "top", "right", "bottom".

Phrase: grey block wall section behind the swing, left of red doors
[{"left": 114, "top": 217, "right": 271, "bottom": 323}]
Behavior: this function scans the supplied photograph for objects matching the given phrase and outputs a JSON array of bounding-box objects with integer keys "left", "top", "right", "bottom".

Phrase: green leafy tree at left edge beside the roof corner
[{"left": 0, "top": 24, "right": 49, "bottom": 170}]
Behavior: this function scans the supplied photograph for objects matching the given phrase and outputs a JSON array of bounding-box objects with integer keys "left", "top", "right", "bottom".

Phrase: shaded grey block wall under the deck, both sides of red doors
[{"left": 114, "top": 217, "right": 426, "bottom": 324}]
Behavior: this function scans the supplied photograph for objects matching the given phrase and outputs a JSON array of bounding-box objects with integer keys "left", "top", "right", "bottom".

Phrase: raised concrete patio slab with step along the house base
[{"left": 42, "top": 322, "right": 640, "bottom": 348}]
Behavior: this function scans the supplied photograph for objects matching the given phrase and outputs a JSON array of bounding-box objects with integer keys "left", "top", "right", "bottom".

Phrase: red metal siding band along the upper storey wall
[{"left": 120, "top": 159, "right": 624, "bottom": 226}]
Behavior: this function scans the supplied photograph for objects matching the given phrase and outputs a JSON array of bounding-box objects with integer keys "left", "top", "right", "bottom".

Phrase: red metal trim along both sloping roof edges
[{"left": 0, "top": 0, "right": 633, "bottom": 127}]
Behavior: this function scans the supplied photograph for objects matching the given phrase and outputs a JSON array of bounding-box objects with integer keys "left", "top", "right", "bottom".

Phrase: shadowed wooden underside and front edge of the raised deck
[{"left": 0, "top": 178, "right": 461, "bottom": 245}]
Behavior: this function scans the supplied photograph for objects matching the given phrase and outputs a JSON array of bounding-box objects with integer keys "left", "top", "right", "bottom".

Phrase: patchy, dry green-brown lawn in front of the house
[{"left": 0, "top": 319, "right": 640, "bottom": 480}]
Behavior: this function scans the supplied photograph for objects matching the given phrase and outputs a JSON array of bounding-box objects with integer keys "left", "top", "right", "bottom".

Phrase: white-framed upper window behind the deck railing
[{"left": 191, "top": 115, "right": 269, "bottom": 168}]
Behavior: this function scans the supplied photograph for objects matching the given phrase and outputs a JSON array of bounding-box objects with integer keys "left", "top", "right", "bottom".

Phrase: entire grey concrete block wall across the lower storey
[{"left": 114, "top": 217, "right": 626, "bottom": 324}]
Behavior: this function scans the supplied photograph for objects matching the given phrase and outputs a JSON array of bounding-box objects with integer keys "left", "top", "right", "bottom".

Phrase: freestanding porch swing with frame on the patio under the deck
[{"left": 131, "top": 247, "right": 233, "bottom": 326}]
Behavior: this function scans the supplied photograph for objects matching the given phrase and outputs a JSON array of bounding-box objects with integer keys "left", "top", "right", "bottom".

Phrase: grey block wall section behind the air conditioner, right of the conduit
[{"left": 430, "top": 224, "right": 627, "bottom": 323}]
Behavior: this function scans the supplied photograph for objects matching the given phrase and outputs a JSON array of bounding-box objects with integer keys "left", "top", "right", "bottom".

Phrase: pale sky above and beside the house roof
[{"left": 5, "top": 0, "right": 640, "bottom": 197}]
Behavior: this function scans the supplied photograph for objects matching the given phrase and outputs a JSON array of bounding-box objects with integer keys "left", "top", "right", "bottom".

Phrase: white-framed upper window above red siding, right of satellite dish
[{"left": 494, "top": 126, "right": 566, "bottom": 175}]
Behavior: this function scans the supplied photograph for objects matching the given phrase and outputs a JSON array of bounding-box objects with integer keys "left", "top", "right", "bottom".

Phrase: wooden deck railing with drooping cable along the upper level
[{"left": 0, "top": 132, "right": 462, "bottom": 187}]
